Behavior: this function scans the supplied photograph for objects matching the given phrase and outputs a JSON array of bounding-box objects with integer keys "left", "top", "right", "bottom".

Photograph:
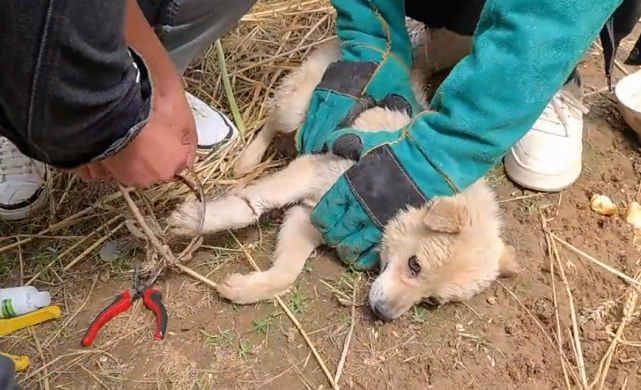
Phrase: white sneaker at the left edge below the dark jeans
[{"left": 0, "top": 137, "right": 49, "bottom": 221}]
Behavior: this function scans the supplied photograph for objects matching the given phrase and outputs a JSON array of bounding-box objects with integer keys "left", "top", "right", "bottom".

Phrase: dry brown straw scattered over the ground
[{"left": 0, "top": 0, "right": 641, "bottom": 390}]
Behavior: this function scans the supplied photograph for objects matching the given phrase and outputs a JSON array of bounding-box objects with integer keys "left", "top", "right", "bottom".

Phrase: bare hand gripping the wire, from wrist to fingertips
[{"left": 74, "top": 74, "right": 198, "bottom": 187}]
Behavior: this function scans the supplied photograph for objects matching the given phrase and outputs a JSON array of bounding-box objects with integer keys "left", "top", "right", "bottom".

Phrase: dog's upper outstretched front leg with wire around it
[{"left": 167, "top": 155, "right": 331, "bottom": 235}]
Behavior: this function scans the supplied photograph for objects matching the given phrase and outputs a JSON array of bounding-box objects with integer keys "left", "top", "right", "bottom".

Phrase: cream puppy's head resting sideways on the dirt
[{"left": 369, "top": 181, "right": 517, "bottom": 321}]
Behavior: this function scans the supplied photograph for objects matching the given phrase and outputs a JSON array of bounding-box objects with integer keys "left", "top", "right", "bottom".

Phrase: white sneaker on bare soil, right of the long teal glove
[{"left": 504, "top": 90, "right": 588, "bottom": 192}]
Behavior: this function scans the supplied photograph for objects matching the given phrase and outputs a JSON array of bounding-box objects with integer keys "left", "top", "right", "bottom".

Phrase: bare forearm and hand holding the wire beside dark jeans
[{"left": 74, "top": 0, "right": 198, "bottom": 187}]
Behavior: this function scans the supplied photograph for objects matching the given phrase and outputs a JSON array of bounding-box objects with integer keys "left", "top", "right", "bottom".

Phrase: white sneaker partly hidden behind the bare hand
[{"left": 185, "top": 92, "right": 239, "bottom": 155}]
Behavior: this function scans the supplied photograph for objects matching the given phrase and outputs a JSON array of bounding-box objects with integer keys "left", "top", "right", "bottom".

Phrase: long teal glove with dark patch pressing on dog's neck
[{"left": 311, "top": 0, "right": 621, "bottom": 270}]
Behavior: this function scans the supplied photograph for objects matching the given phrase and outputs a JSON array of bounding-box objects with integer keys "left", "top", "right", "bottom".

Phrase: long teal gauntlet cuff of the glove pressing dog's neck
[{"left": 408, "top": 0, "right": 621, "bottom": 195}]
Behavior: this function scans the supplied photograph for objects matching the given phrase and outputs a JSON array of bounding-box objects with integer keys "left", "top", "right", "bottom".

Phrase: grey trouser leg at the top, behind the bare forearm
[{"left": 138, "top": 0, "right": 257, "bottom": 72}]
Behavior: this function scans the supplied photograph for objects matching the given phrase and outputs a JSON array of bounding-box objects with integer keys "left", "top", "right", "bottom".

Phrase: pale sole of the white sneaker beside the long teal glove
[{"left": 503, "top": 154, "right": 583, "bottom": 192}]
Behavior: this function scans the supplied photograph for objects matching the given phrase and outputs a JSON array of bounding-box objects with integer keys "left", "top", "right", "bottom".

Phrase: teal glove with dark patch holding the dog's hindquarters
[{"left": 296, "top": 0, "right": 421, "bottom": 154}]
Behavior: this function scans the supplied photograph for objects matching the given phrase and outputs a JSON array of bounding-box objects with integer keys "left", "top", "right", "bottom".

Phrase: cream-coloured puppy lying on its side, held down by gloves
[{"left": 169, "top": 32, "right": 517, "bottom": 320}]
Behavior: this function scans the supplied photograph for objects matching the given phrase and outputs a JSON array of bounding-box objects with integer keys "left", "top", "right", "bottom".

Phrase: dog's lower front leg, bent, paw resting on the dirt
[{"left": 217, "top": 206, "right": 322, "bottom": 304}]
